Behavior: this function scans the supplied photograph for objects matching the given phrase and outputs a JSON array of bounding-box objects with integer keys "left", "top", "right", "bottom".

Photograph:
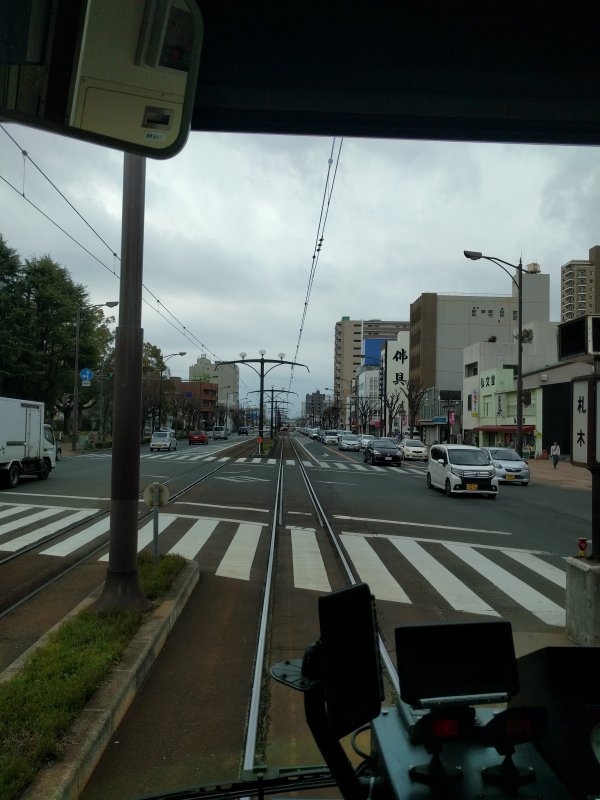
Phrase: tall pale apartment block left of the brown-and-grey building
[{"left": 333, "top": 317, "right": 410, "bottom": 424}]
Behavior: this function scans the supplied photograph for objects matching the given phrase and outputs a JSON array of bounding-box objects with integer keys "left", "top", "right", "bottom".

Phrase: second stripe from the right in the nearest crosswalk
[{"left": 446, "top": 545, "right": 566, "bottom": 627}]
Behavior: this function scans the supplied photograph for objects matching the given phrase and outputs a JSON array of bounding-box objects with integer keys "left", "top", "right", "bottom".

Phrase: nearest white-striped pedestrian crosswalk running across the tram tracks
[{"left": 0, "top": 503, "right": 566, "bottom": 627}]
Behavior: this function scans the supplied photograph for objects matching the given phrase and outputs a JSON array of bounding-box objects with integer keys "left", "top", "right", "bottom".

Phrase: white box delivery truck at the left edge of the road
[{"left": 0, "top": 397, "right": 56, "bottom": 489}]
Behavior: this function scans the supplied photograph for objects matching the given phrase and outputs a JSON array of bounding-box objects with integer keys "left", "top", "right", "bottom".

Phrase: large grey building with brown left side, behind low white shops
[{"left": 410, "top": 264, "right": 550, "bottom": 391}]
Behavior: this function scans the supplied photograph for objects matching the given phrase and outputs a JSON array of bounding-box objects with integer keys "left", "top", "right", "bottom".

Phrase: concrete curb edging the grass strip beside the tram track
[{"left": 15, "top": 561, "right": 200, "bottom": 800}]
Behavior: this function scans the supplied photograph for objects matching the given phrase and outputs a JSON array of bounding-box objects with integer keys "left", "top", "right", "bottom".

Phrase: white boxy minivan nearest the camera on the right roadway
[{"left": 427, "top": 444, "right": 498, "bottom": 499}]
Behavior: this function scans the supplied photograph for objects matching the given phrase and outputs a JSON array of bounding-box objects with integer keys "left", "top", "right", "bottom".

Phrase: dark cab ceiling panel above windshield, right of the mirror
[{"left": 192, "top": 0, "right": 600, "bottom": 144}]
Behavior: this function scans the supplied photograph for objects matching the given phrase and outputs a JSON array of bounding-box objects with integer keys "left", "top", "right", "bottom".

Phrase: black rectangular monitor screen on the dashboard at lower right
[{"left": 395, "top": 620, "right": 519, "bottom": 708}]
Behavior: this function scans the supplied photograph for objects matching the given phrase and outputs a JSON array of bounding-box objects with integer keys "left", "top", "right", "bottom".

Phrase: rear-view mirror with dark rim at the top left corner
[{"left": 0, "top": 0, "right": 203, "bottom": 158}]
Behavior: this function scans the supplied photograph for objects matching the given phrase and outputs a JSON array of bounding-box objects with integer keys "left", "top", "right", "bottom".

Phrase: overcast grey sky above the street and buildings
[{"left": 0, "top": 124, "right": 600, "bottom": 413}]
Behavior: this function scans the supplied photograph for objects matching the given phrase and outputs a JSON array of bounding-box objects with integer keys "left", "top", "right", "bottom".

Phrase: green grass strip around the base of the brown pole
[{"left": 0, "top": 553, "right": 185, "bottom": 800}]
